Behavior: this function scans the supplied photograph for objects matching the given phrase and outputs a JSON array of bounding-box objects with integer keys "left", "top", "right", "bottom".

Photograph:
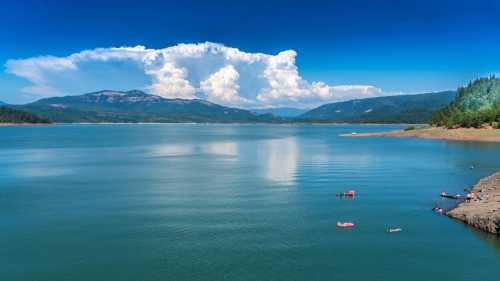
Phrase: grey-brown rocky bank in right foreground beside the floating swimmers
[{"left": 447, "top": 172, "right": 500, "bottom": 235}]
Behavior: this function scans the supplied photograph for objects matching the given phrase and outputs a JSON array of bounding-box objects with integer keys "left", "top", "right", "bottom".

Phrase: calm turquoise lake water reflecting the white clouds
[{"left": 0, "top": 124, "right": 500, "bottom": 281}]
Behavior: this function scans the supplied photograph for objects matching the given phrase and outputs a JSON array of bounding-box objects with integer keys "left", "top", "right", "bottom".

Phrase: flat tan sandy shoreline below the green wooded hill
[{"left": 341, "top": 127, "right": 500, "bottom": 142}]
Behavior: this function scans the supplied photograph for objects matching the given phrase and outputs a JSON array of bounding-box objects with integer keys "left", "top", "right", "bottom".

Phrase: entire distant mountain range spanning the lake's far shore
[{"left": 2, "top": 90, "right": 456, "bottom": 123}]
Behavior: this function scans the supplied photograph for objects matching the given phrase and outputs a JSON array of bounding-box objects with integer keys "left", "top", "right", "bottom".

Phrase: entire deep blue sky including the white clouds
[{"left": 0, "top": 0, "right": 500, "bottom": 107}]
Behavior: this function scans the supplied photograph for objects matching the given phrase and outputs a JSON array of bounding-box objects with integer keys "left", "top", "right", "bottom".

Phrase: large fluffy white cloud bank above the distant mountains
[{"left": 6, "top": 42, "right": 394, "bottom": 107}]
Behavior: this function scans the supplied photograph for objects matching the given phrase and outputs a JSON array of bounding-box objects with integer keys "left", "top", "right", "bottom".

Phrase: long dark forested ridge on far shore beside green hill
[{"left": 298, "top": 91, "right": 456, "bottom": 123}]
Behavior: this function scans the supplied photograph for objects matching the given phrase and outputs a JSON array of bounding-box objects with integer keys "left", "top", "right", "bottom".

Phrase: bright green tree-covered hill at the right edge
[{"left": 430, "top": 76, "right": 500, "bottom": 128}]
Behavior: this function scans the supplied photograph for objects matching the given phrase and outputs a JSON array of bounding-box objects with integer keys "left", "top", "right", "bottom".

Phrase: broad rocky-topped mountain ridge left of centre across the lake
[{"left": 16, "top": 90, "right": 281, "bottom": 123}]
